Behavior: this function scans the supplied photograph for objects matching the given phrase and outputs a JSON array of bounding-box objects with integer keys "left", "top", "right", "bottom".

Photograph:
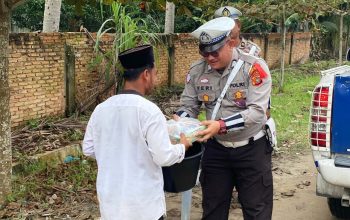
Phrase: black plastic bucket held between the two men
[{"left": 162, "top": 142, "right": 204, "bottom": 193}]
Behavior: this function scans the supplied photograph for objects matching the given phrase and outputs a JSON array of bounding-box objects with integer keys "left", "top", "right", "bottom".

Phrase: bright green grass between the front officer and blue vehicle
[{"left": 271, "top": 61, "right": 336, "bottom": 152}]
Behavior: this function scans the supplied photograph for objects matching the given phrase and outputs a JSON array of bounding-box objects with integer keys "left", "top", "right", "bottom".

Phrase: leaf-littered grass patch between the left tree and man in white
[{"left": 7, "top": 157, "right": 97, "bottom": 205}]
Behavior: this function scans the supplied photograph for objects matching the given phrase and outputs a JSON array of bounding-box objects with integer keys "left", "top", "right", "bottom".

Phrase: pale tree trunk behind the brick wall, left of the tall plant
[{"left": 43, "top": 0, "right": 62, "bottom": 32}]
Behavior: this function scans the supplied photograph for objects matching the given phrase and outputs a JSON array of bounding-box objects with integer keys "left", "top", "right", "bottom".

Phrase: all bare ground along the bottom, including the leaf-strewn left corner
[{"left": 0, "top": 150, "right": 336, "bottom": 220}]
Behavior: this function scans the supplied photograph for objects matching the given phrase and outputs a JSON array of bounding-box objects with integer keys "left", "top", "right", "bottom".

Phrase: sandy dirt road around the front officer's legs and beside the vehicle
[{"left": 167, "top": 151, "right": 336, "bottom": 220}]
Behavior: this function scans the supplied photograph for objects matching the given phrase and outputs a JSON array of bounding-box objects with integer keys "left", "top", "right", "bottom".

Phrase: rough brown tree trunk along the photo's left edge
[{"left": 0, "top": 0, "right": 12, "bottom": 207}]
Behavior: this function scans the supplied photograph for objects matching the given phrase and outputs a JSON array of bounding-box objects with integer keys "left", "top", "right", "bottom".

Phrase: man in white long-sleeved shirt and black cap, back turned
[{"left": 83, "top": 45, "right": 190, "bottom": 220}]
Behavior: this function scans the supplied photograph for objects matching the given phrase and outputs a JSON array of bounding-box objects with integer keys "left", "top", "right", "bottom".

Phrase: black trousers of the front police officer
[{"left": 200, "top": 137, "right": 273, "bottom": 220}]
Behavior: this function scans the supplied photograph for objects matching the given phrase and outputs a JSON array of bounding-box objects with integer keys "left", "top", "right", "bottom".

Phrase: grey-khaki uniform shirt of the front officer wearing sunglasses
[{"left": 177, "top": 49, "right": 271, "bottom": 142}]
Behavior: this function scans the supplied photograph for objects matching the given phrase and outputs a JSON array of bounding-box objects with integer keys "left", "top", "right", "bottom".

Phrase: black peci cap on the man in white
[{"left": 118, "top": 44, "right": 154, "bottom": 69}]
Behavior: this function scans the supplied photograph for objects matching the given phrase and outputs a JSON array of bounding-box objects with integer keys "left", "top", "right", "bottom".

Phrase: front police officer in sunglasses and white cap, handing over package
[{"left": 176, "top": 17, "right": 273, "bottom": 220}]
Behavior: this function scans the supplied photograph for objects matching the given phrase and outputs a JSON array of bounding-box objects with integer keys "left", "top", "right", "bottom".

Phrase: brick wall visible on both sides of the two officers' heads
[{"left": 170, "top": 33, "right": 311, "bottom": 83}]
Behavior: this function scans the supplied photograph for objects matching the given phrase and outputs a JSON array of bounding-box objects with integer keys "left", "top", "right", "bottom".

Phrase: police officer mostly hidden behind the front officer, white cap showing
[{"left": 214, "top": 6, "right": 261, "bottom": 56}]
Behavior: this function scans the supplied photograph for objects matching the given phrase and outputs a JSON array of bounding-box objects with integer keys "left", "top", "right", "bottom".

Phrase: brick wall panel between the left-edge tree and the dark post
[{"left": 9, "top": 33, "right": 64, "bottom": 126}]
